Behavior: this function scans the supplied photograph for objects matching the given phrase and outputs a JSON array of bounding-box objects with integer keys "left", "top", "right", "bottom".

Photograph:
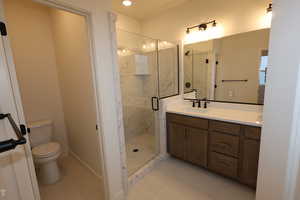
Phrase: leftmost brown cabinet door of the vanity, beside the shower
[{"left": 168, "top": 123, "right": 186, "bottom": 159}]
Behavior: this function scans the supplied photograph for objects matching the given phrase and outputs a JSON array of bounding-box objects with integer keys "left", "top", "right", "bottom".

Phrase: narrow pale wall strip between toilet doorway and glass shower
[{"left": 5, "top": 0, "right": 127, "bottom": 199}]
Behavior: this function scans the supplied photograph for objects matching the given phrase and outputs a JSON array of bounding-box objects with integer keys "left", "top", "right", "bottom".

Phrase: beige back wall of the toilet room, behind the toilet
[{"left": 4, "top": 0, "right": 68, "bottom": 152}]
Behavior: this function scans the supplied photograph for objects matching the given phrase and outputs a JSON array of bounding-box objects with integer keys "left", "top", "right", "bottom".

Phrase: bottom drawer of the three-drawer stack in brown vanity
[{"left": 209, "top": 152, "right": 238, "bottom": 178}]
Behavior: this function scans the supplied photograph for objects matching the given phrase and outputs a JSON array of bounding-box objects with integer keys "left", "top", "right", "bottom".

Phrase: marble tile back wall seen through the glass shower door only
[{"left": 119, "top": 53, "right": 157, "bottom": 142}]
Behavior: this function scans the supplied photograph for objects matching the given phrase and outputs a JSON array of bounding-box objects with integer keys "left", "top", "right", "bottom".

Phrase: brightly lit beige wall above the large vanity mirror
[{"left": 142, "top": 0, "right": 270, "bottom": 41}]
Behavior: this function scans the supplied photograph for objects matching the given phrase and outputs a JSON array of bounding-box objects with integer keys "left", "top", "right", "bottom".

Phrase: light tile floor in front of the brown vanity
[{"left": 128, "top": 158, "right": 255, "bottom": 200}]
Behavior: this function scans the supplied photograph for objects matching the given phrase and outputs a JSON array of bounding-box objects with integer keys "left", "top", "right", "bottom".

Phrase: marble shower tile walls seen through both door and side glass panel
[{"left": 119, "top": 48, "right": 178, "bottom": 140}]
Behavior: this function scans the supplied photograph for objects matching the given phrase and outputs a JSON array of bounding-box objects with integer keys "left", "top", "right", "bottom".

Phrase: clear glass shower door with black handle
[{"left": 117, "top": 30, "right": 159, "bottom": 175}]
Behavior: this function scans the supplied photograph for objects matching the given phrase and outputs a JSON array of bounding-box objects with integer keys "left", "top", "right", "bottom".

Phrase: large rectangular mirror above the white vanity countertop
[{"left": 184, "top": 29, "right": 270, "bottom": 104}]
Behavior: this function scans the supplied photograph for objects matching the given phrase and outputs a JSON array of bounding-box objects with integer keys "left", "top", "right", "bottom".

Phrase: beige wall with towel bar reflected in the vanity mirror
[{"left": 215, "top": 29, "right": 270, "bottom": 103}]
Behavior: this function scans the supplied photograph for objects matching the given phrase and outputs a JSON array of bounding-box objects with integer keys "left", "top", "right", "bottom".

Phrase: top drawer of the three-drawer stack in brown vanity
[{"left": 210, "top": 121, "right": 241, "bottom": 135}]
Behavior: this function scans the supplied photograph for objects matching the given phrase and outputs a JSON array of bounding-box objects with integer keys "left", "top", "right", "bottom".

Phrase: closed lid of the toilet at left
[{"left": 32, "top": 142, "right": 60, "bottom": 157}]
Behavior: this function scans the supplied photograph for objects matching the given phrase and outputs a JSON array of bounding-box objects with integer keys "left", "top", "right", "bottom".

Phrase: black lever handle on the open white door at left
[{"left": 0, "top": 113, "right": 27, "bottom": 153}]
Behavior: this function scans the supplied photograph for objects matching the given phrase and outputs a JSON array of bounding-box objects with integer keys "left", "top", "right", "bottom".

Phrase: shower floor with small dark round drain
[{"left": 126, "top": 134, "right": 156, "bottom": 175}]
